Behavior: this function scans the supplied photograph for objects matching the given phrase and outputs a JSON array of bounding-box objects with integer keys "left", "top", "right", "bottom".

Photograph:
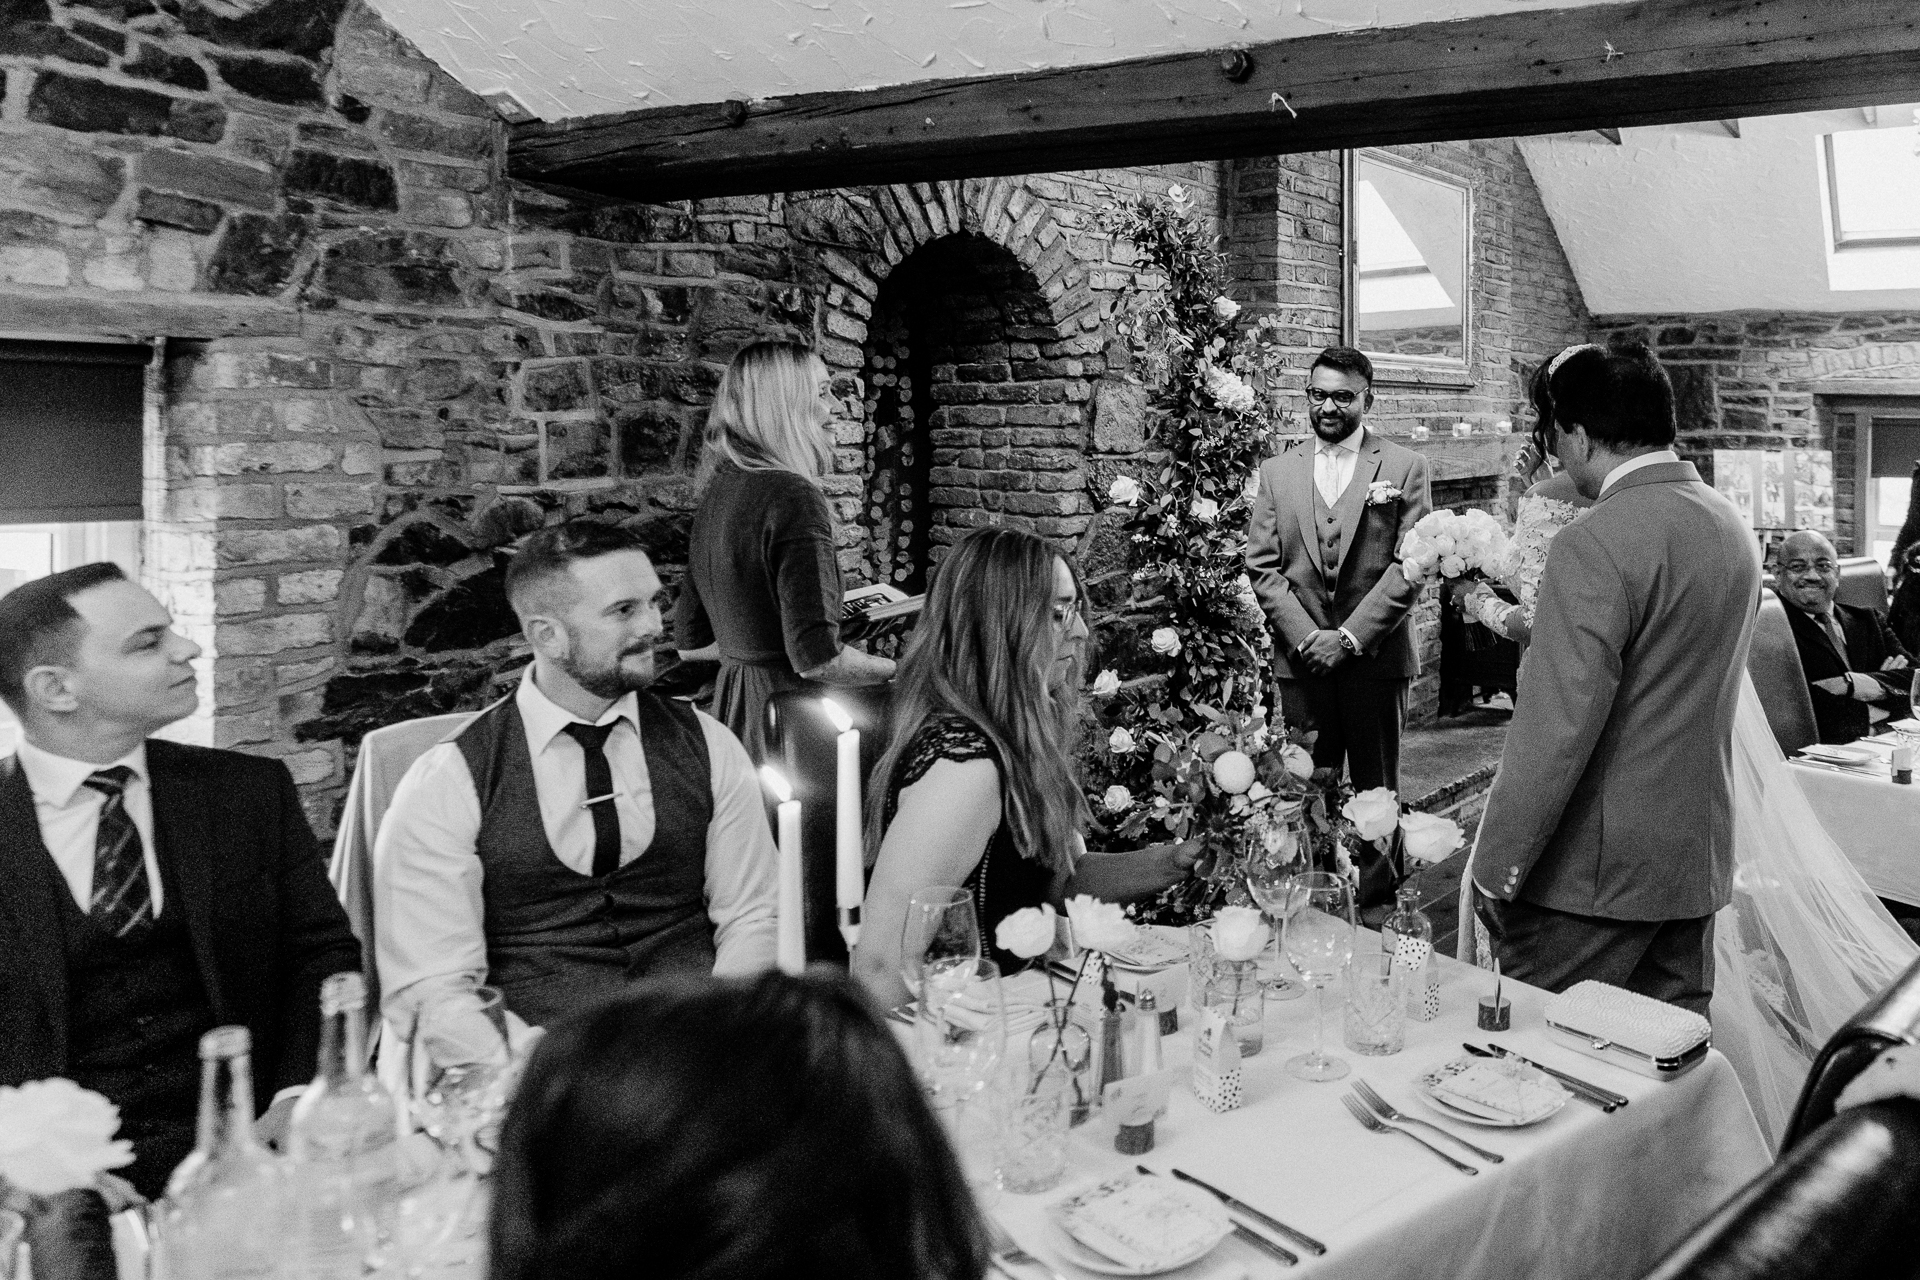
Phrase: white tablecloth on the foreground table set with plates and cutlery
[{"left": 987, "top": 948, "right": 1768, "bottom": 1280}]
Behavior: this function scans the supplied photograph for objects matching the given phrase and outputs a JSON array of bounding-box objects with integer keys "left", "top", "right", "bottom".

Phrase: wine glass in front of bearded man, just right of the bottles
[{"left": 407, "top": 986, "right": 513, "bottom": 1161}]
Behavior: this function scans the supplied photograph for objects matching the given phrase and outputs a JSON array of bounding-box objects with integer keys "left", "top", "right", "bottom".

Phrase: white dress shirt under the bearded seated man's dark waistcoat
[{"left": 372, "top": 666, "right": 778, "bottom": 1021}]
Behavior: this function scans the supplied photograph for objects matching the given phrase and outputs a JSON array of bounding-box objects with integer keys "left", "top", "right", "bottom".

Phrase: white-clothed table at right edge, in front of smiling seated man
[{"left": 1789, "top": 720, "right": 1920, "bottom": 908}]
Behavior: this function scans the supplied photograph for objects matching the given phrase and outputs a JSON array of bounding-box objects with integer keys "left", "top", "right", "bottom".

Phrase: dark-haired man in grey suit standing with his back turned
[{"left": 1473, "top": 345, "right": 1761, "bottom": 1013}]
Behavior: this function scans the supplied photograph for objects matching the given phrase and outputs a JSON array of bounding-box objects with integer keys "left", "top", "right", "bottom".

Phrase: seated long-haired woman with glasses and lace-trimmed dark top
[{"left": 852, "top": 528, "right": 1200, "bottom": 1006}]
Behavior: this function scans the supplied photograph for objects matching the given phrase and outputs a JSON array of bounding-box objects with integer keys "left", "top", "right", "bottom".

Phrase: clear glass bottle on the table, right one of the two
[{"left": 288, "top": 973, "right": 399, "bottom": 1280}]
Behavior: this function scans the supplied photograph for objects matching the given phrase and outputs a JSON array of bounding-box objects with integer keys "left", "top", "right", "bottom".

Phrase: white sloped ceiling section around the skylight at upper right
[{"left": 1521, "top": 107, "right": 1920, "bottom": 315}]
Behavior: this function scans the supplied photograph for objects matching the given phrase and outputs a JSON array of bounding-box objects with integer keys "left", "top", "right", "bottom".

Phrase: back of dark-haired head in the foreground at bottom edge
[{"left": 488, "top": 969, "right": 989, "bottom": 1280}]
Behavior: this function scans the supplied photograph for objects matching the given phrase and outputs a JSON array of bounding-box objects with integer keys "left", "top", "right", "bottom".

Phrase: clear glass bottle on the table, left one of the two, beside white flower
[{"left": 154, "top": 1027, "right": 286, "bottom": 1280}]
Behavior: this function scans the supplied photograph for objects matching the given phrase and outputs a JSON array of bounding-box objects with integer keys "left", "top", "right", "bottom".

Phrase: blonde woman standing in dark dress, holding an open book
[{"left": 674, "top": 342, "right": 893, "bottom": 764}]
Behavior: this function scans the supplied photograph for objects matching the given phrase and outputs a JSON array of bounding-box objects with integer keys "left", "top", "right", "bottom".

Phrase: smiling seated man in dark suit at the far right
[{"left": 1774, "top": 530, "right": 1912, "bottom": 743}]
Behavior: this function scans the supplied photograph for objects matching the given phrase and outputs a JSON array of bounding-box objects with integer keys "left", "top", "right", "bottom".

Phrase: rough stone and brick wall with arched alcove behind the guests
[{"left": 0, "top": 0, "right": 1578, "bottom": 829}]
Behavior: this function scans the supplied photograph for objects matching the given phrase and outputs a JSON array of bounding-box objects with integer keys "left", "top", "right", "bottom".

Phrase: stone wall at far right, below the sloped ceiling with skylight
[{"left": 1596, "top": 311, "right": 1920, "bottom": 555}]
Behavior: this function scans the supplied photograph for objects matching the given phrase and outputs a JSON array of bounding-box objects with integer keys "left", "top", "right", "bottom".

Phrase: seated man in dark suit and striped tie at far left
[{"left": 0, "top": 564, "right": 359, "bottom": 1196}]
